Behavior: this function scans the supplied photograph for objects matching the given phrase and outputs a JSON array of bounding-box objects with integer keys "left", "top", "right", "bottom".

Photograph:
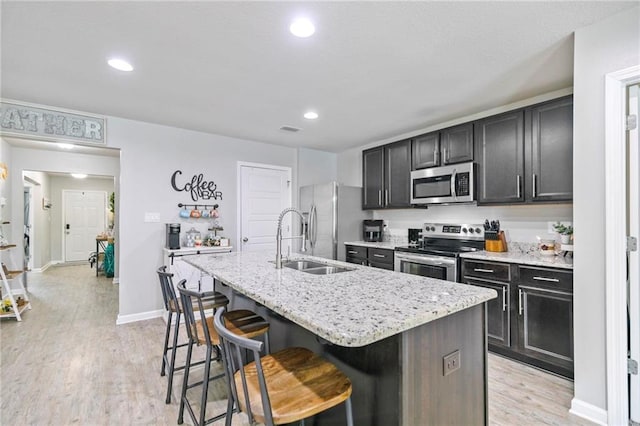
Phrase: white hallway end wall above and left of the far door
[{"left": 50, "top": 175, "right": 115, "bottom": 262}]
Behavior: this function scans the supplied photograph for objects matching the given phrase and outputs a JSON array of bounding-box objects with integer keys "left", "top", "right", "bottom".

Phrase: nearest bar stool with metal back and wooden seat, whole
[{"left": 214, "top": 308, "right": 353, "bottom": 426}]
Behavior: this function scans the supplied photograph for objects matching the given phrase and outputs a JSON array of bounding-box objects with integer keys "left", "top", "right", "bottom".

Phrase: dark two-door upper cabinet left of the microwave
[{"left": 362, "top": 140, "right": 411, "bottom": 209}]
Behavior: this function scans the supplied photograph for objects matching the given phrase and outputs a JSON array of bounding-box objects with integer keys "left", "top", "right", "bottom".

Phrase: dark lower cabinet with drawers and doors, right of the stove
[{"left": 462, "top": 259, "right": 573, "bottom": 378}]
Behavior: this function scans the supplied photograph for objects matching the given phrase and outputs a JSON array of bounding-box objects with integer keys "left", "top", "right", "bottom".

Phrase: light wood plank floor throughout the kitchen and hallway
[{"left": 0, "top": 265, "right": 590, "bottom": 426}]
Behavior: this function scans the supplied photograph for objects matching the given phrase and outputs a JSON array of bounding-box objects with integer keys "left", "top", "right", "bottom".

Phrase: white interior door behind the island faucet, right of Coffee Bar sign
[{"left": 238, "top": 164, "right": 291, "bottom": 253}]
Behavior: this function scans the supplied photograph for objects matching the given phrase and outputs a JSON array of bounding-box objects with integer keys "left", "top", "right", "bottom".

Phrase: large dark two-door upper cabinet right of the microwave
[{"left": 475, "top": 96, "right": 573, "bottom": 204}]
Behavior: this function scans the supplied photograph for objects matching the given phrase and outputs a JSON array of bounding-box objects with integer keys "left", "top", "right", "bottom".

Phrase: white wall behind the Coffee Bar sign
[{"left": 107, "top": 117, "right": 297, "bottom": 322}]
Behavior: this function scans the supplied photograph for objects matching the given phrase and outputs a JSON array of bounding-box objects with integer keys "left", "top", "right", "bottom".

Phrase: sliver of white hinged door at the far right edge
[{"left": 627, "top": 85, "right": 640, "bottom": 424}]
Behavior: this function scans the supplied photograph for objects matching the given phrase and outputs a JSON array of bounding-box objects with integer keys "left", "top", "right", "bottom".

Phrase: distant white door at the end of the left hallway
[{"left": 62, "top": 190, "right": 107, "bottom": 262}]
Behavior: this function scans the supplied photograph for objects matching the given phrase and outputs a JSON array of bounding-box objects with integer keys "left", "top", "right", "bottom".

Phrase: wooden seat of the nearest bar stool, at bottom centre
[{"left": 234, "top": 348, "right": 352, "bottom": 425}]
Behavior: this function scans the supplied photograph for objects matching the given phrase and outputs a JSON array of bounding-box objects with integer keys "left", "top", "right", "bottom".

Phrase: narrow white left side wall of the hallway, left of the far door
[{"left": 22, "top": 170, "right": 51, "bottom": 269}]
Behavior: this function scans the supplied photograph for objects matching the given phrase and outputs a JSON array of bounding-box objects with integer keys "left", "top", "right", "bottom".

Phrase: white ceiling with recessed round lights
[{"left": 0, "top": 0, "right": 637, "bottom": 152}]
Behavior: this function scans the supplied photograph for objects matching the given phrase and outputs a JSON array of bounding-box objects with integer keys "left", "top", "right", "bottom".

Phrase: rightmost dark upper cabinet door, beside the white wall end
[{"left": 525, "top": 96, "right": 573, "bottom": 202}]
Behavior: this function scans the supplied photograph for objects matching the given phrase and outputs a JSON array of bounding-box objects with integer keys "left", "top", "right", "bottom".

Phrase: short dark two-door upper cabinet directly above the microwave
[{"left": 411, "top": 123, "right": 473, "bottom": 170}]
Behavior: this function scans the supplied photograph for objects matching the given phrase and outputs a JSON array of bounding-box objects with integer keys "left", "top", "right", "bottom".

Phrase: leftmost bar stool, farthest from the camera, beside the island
[{"left": 157, "top": 266, "right": 229, "bottom": 404}]
